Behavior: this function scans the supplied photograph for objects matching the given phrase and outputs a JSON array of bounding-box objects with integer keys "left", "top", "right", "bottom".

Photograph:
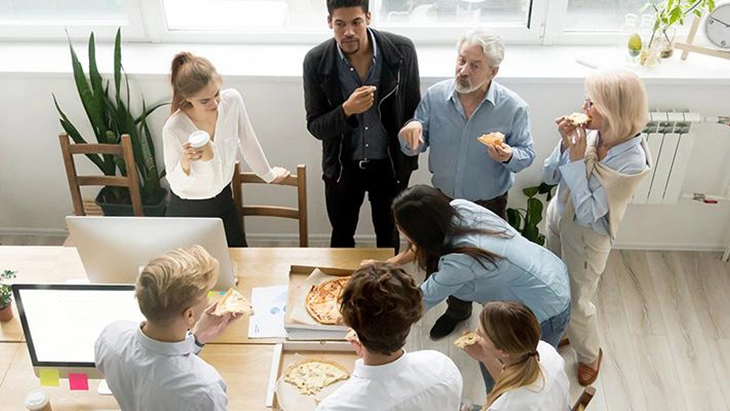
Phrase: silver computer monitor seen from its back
[{"left": 66, "top": 216, "right": 236, "bottom": 290}]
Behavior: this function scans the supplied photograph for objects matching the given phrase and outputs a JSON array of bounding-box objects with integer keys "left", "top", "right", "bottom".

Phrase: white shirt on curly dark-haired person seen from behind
[{"left": 317, "top": 350, "right": 463, "bottom": 411}]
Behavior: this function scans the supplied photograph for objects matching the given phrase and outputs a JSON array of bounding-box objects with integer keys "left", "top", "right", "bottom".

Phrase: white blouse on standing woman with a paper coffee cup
[{"left": 162, "top": 89, "right": 275, "bottom": 200}]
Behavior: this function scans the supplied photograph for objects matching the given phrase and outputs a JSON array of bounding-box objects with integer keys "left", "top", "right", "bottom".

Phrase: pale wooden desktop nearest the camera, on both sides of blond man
[{"left": 0, "top": 343, "right": 274, "bottom": 411}]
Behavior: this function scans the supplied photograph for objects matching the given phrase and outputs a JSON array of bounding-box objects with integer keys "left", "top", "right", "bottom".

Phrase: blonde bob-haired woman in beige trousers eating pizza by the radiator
[{"left": 543, "top": 69, "right": 651, "bottom": 385}]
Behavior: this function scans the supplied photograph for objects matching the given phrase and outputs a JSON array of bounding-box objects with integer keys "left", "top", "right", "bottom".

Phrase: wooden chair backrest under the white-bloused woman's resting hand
[{"left": 233, "top": 164, "right": 309, "bottom": 247}]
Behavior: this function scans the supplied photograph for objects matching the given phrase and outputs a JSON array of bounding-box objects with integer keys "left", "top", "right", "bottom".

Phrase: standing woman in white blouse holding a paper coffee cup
[{"left": 162, "top": 52, "right": 289, "bottom": 247}]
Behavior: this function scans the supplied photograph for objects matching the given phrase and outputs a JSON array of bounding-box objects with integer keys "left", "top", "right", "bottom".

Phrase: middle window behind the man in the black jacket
[{"left": 155, "top": 0, "right": 538, "bottom": 43}]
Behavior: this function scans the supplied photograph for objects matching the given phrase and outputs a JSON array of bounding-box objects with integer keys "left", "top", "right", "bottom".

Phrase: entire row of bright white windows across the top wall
[{"left": 0, "top": 0, "right": 700, "bottom": 45}]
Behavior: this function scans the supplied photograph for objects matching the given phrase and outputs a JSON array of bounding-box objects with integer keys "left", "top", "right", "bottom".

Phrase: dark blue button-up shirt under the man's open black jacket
[{"left": 337, "top": 29, "right": 388, "bottom": 160}]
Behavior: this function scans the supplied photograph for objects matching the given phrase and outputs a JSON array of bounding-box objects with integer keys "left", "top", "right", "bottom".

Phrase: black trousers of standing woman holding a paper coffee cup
[{"left": 165, "top": 185, "right": 248, "bottom": 247}]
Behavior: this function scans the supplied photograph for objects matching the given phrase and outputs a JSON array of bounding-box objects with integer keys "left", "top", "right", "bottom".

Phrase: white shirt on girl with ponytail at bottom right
[{"left": 489, "top": 341, "right": 570, "bottom": 411}]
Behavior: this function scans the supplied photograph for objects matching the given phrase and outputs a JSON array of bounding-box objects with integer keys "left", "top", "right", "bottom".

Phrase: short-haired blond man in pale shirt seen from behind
[{"left": 95, "top": 246, "right": 239, "bottom": 411}]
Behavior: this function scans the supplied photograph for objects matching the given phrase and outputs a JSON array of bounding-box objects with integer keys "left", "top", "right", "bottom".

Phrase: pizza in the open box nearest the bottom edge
[{"left": 284, "top": 359, "right": 350, "bottom": 395}]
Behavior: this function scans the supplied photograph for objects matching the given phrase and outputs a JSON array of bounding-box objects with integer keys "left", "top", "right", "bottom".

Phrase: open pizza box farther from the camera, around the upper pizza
[{"left": 284, "top": 265, "right": 353, "bottom": 341}]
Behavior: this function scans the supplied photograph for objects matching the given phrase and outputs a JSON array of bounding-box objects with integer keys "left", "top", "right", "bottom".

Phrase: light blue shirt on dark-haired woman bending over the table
[{"left": 421, "top": 200, "right": 570, "bottom": 322}]
